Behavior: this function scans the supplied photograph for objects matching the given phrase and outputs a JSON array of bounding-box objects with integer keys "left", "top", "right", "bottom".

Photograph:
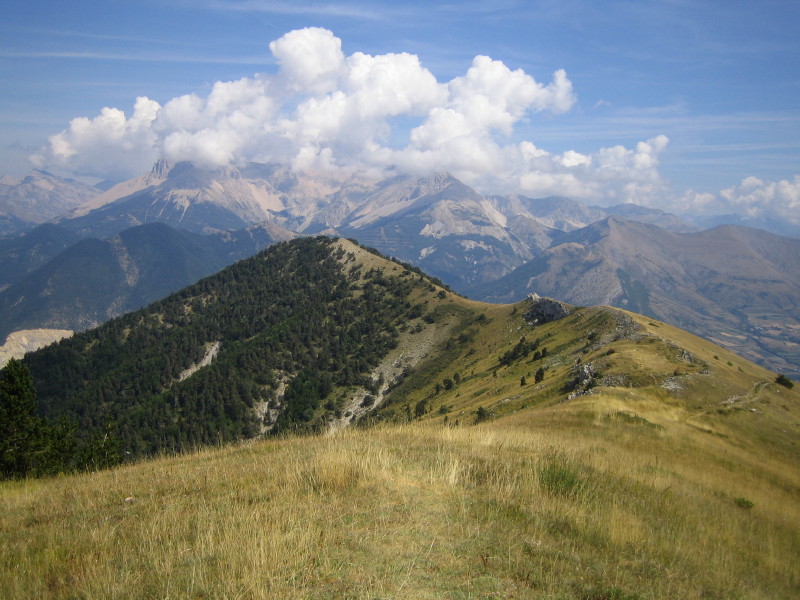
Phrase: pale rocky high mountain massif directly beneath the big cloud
[{"left": 45, "top": 161, "right": 688, "bottom": 288}]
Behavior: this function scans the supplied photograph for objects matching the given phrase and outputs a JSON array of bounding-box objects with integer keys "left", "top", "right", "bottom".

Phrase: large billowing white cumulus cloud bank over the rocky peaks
[{"left": 32, "top": 27, "right": 720, "bottom": 213}]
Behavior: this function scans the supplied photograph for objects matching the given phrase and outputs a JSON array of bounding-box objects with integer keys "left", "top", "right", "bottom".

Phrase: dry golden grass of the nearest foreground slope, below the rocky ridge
[{"left": 0, "top": 399, "right": 800, "bottom": 600}]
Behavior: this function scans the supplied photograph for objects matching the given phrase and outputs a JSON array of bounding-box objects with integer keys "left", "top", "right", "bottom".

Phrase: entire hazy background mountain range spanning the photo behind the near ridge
[{"left": 0, "top": 160, "right": 800, "bottom": 375}]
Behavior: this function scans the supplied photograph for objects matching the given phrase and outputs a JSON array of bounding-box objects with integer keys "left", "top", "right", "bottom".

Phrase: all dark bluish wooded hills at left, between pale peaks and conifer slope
[{"left": 0, "top": 223, "right": 297, "bottom": 339}]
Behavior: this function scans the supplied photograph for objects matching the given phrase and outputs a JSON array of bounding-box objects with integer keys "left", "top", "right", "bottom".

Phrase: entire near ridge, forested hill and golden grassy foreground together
[{"left": 0, "top": 238, "right": 800, "bottom": 599}]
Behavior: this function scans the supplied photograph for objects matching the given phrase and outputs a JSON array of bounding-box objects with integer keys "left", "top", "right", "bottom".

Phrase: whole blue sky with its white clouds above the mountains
[{"left": 0, "top": 0, "right": 800, "bottom": 219}]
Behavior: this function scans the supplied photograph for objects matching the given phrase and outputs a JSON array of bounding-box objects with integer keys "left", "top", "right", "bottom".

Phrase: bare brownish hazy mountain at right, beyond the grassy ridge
[{"left": 471, "top": 217, "right": 800, "bottom": 374}]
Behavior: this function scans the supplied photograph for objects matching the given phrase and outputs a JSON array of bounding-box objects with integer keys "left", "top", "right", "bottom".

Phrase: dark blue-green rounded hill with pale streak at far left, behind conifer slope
[{"left": 0, "top": 223, "right": 230, "bottom": 337}]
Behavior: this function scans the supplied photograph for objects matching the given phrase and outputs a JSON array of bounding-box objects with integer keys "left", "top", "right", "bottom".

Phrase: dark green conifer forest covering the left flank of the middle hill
[{"left": 12, "top": 238, "right": 430, "bottom": 457}]
